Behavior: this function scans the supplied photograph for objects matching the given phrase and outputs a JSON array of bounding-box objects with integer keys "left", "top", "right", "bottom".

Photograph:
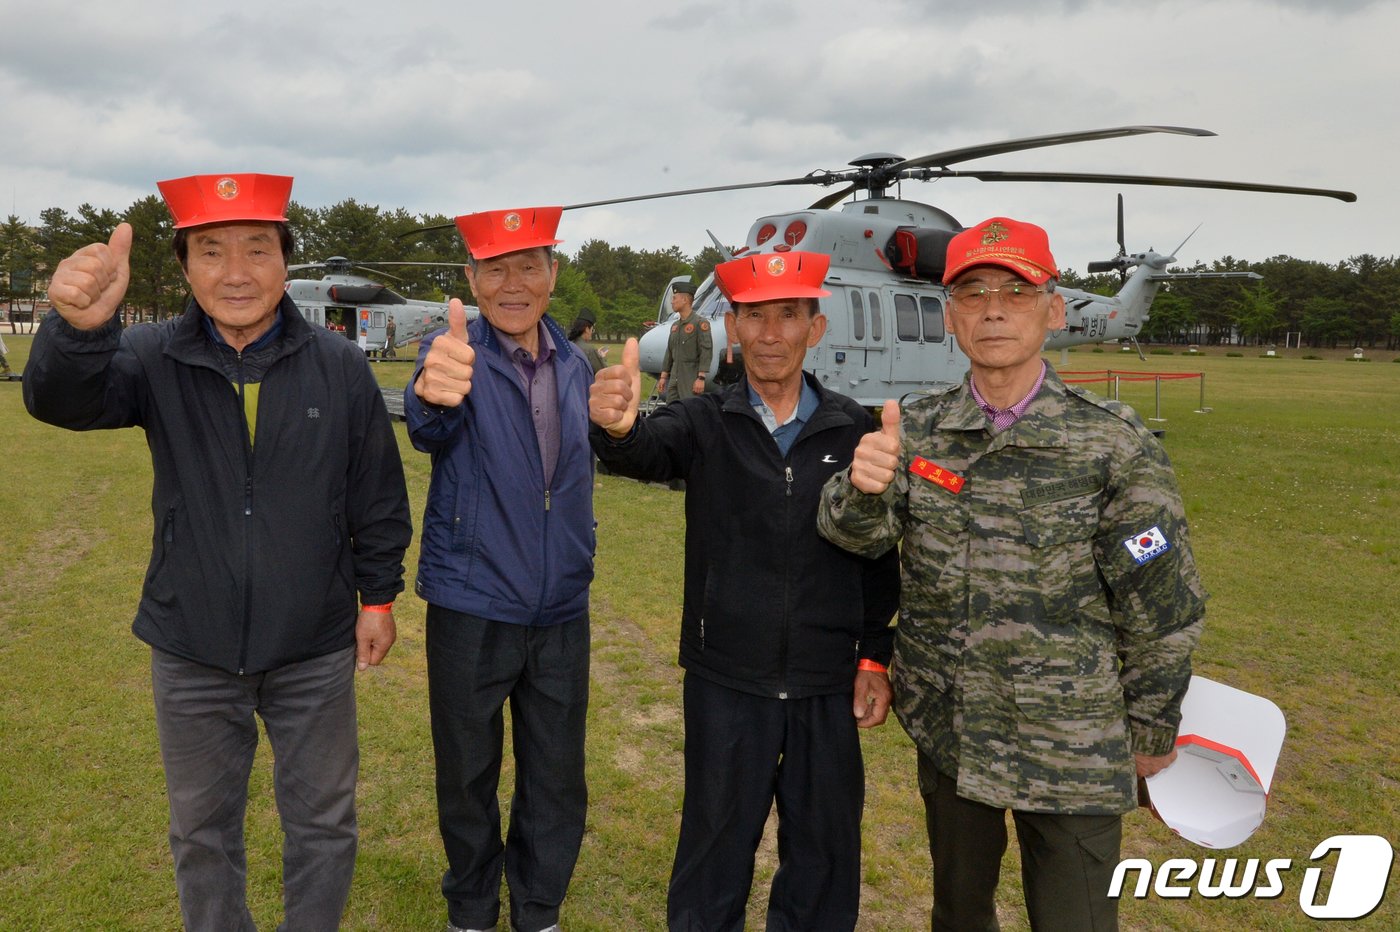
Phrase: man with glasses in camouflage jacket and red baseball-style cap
[{"left": 818, "top": 217, "right": 1205, "bottom": 931}]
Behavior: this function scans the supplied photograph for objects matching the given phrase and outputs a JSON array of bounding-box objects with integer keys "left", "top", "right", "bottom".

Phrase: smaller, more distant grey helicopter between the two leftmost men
[{"left": 286, "top": 256, "right": 477, "bottom": 355}]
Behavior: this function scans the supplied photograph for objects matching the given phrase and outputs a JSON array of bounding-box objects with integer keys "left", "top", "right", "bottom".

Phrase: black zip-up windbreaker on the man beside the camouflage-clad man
[{"left": 591, "top": 376, "right": 899, "bottom": 698}]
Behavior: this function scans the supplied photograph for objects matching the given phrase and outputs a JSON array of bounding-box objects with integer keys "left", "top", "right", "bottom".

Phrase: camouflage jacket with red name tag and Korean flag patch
[{"left": 818, "top": 371, "right": 1205, "bottom": 814}]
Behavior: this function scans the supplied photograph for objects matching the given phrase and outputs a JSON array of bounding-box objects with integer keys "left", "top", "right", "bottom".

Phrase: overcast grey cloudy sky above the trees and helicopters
[{"left": 0, "top": 0, "right": 1400, "bottom": 270}]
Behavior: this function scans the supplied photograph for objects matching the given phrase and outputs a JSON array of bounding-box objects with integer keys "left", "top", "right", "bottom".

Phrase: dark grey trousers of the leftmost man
[{"left": 151, "top": 647, "right": 360, "bottom": 932}]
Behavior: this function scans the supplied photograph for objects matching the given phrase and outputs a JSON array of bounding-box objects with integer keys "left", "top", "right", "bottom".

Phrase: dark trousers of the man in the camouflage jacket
[{"left": 918, "top": 753, "right": 1123, "bottom": 932}]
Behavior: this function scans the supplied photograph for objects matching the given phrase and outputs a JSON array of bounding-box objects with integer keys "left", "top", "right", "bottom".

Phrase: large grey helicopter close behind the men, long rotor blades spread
[{"left": 582, "top": 126, "right": 1357, "bottom": 407}]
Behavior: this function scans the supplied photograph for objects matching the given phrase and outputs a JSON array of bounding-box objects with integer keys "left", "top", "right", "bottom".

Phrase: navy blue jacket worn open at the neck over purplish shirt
[{"left": 403, "top": 316, "right": 595, "bottom": 626}]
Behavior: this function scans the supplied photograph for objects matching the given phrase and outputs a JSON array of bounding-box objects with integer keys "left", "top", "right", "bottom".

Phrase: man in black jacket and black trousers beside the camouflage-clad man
[{"left": 589, "top": 252, "right": 899, "bottom": 931}]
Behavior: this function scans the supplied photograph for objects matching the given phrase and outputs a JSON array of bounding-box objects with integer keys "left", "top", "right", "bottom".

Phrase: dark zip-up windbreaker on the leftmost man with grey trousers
[{"left": 24, "top": 295, "right": 412, "bottom": 673}]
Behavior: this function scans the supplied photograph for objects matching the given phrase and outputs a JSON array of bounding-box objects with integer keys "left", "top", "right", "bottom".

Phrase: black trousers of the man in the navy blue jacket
[{"left": 427, "top": 605, "right": 589, "bottom": 932}]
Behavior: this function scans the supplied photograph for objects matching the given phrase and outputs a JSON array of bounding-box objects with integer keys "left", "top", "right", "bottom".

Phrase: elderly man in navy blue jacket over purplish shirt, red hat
[{"left": 405, "top": 207, "right": 594, "bottom": 932}]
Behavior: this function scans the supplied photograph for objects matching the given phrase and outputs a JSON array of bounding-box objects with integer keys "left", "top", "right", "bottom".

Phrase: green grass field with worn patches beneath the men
[{"left": 0, "top": 333, "right": 1400, "bottom": 932}]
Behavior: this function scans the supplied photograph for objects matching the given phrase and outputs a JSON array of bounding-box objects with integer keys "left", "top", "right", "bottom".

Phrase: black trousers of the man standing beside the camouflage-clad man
[{"left": 666, "top": 670, "right": 865, "bottom": 932}]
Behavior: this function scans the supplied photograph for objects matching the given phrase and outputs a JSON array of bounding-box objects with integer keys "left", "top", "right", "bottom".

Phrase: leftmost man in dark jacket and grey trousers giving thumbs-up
[{"left": 24, "top": 175, "right": 412, "bottom": 931}]
